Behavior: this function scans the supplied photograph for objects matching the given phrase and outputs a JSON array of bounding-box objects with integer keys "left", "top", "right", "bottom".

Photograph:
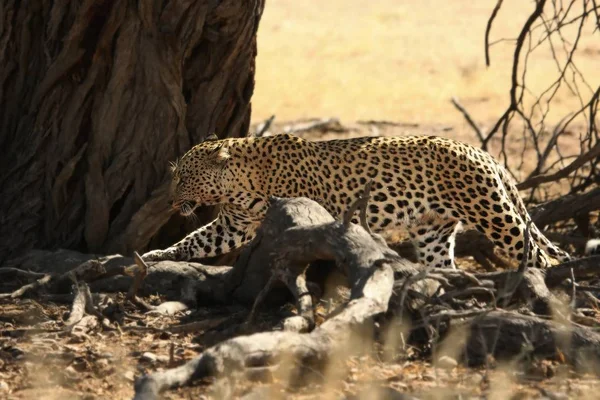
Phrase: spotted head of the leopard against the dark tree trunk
[{"left": 171, "top": 134, "right": 231, "bottom": 216}]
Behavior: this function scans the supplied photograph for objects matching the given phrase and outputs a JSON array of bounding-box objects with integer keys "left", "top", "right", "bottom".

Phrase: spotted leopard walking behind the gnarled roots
[{"left": 142, "top": 134, "right": 571, "bottom": 268}]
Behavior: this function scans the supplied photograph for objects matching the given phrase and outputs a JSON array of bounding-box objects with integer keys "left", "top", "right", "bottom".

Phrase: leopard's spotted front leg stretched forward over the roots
[{"left": 142, "top": 205, "right": 259, "bottom": 261}]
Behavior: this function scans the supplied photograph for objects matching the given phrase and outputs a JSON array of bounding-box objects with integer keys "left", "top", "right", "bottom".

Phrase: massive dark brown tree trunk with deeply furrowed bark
[{"left": 0, "top": 0, "right": 264, "bottom": 263}]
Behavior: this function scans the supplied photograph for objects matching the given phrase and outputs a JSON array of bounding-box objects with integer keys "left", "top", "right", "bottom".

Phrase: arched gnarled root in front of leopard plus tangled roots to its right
[{"left": 136, "top": 194, "right": 600, "bottom": 399}]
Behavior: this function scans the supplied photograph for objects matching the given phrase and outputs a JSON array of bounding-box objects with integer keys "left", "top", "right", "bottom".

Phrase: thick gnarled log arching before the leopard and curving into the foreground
[{"left": 135, "top": 191, "right": 415, "bottom": 399}]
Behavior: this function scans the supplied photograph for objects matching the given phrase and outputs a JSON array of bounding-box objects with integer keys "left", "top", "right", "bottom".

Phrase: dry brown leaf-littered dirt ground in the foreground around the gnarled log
[{"left": 0, "top": 299, "right": 600, "bottom": 399}]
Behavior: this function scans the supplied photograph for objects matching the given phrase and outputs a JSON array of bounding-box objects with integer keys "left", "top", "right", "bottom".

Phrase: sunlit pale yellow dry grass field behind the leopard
[{"left": 253, "top": 0, "right": 600, "bottom": 124}]
